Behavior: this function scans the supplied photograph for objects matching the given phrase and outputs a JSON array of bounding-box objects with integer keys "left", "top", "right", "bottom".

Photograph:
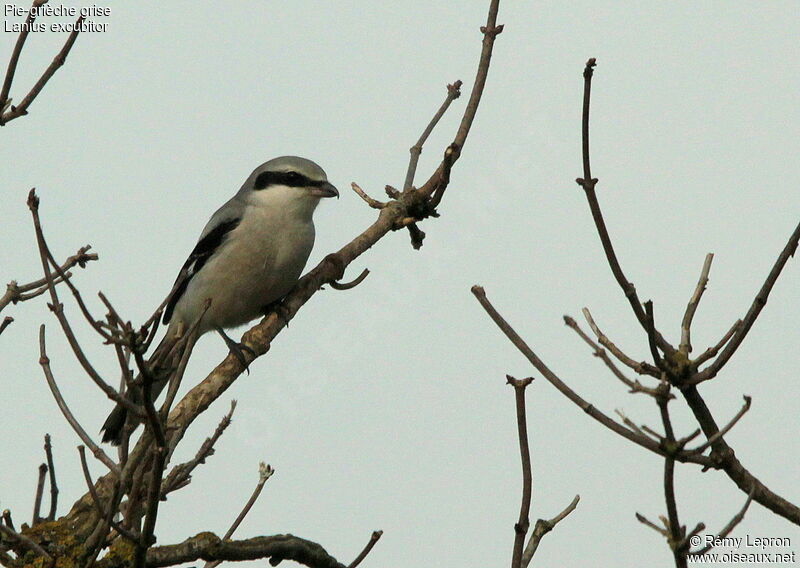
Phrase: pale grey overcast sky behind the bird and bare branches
[{"left": 0, "top": 0, "right": 800, "bottom": 568}]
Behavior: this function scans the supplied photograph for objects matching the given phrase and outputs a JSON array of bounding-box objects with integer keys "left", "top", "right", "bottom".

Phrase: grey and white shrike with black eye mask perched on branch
[{"left": 101, "top": 156, "right": 339, "bottom": 445}]
